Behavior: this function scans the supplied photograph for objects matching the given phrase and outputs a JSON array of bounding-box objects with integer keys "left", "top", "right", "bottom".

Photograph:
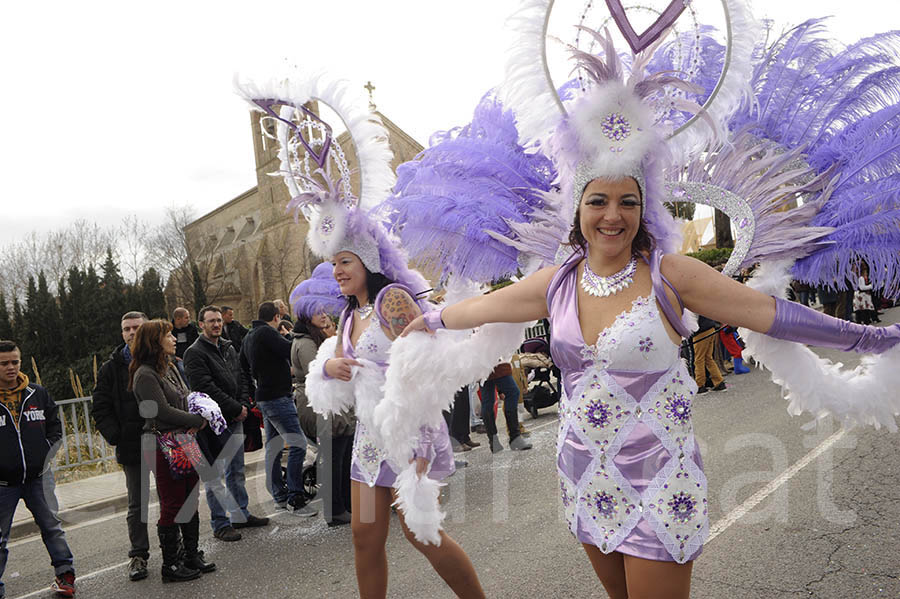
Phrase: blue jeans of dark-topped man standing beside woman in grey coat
[{"left": 257, "top": 396, "right": 306, "bottom": 503}]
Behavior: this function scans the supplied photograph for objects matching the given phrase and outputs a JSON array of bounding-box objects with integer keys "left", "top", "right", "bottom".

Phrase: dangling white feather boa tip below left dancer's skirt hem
[{"left": 394, "top": 462, "right": 445, "bottom": 546}]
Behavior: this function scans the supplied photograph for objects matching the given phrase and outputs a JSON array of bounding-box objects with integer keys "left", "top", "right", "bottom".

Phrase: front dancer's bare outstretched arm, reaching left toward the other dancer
[{"left": 403, "top": 266, "right": 559, "bottom": 335}]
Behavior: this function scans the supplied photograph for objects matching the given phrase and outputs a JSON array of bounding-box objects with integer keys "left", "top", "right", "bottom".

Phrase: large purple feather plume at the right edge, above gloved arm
[{"left": 730, "top": 19, "right": 900, "bottom": 295}]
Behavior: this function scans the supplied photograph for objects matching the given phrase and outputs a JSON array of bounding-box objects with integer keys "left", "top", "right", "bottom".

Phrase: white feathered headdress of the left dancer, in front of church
[{"left": 236, "top": 77, "right": 430, "bottom": 293}]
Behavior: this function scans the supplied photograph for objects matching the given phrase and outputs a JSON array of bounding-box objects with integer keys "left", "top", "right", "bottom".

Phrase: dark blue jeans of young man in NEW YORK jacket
[{"left": 0, "top": 470, "right": 75, "bottom": 597}]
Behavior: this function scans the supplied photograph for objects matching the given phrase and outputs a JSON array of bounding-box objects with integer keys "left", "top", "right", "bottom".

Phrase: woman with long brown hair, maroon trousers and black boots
[{"left": 128, "top": 320, "right": 216, "bottom": 582}]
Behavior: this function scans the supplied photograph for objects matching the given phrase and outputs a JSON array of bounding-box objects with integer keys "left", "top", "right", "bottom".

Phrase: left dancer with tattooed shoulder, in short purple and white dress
[{"left": 307, "top": 250, "right": 484, "bottom": 598}]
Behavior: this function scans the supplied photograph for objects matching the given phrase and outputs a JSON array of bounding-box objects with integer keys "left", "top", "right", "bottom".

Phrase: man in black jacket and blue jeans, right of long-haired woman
[{"left": 184, "top": 306, "right": 269, "bottom": 541}]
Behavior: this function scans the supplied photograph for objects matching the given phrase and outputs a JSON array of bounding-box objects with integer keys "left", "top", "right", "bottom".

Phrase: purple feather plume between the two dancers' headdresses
[{"left": 379, "top": 93, "right": 556, "bottom": 282}]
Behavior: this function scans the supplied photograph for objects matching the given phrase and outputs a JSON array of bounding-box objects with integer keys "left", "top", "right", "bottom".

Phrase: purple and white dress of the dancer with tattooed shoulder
[{"left": 341, "top": 291, "right": 456, "bottom": 487}]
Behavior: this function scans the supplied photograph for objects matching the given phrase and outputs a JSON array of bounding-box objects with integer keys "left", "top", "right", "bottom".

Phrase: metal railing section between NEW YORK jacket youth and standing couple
[{"left": 53, "top": 397, "right": 116, "bottom": 471}]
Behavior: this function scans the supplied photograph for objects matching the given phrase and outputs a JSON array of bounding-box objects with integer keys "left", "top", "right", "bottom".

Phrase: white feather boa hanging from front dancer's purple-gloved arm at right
[{"left": 740, "top": 261, "right": 900, "bottom": 432}]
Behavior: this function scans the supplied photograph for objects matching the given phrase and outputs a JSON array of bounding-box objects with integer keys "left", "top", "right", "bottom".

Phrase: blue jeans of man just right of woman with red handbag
[{"left": 203, "top": 422, "right": 250, "bottom": 532}]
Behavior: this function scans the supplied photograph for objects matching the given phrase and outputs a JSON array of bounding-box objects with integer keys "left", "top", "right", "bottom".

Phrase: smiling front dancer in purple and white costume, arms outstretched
[{"left": 392, "top": 2, "right": 900, "bottom": 599}]
